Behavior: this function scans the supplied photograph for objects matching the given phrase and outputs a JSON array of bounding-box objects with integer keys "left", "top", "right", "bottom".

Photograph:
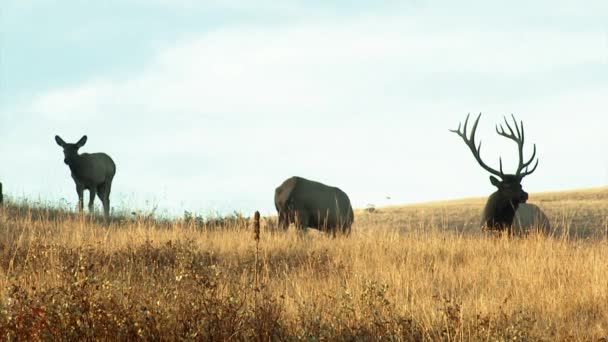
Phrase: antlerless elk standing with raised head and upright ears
[{"left": 55, "top": 135, "right": 116, "bottom": 220}]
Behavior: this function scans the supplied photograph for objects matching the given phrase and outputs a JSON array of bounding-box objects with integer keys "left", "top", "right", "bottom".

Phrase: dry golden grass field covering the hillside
[{"left": 0, "top": 188, "right": 608, "bottom": 341}]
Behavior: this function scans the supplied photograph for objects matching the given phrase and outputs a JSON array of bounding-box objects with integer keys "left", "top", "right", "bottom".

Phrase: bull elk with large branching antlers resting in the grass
[{"left": 450, "top": 113, "right": 546, "bottom": 233}]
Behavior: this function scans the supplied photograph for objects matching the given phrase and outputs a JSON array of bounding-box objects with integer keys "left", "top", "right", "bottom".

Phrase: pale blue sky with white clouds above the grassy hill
[{"left": 0, "top": 0, "right": 608, "bottom": 215}]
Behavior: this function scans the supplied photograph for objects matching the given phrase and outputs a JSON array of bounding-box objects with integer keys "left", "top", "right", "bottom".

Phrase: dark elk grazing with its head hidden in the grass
[{"left": 274, "top": 177, "right": 354, "bottom": 235}]
